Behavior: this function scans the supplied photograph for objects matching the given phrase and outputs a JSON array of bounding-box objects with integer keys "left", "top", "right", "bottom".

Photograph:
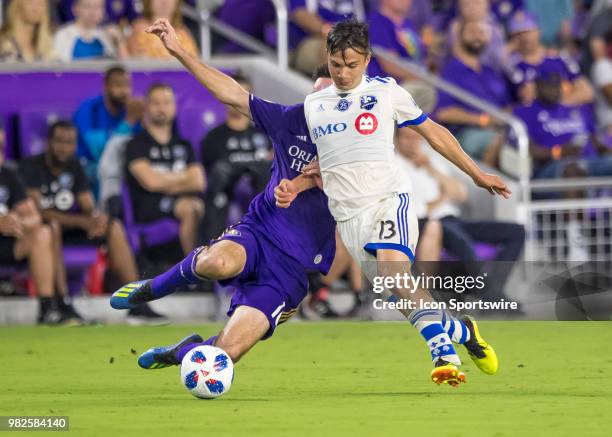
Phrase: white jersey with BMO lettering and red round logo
[{"left": 304, "top": 76, "right": 427, "bottom": 221}]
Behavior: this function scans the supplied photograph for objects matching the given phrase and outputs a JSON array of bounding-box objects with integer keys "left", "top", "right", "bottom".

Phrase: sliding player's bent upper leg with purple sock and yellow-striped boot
[{"left": 110, "top": 229, "right": 250, "bottom": 309}]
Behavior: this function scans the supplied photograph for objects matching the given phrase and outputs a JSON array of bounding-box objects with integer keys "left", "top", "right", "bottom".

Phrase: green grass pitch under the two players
[{"left": 0, "top": 322, "right": 612, "bottom": 437}]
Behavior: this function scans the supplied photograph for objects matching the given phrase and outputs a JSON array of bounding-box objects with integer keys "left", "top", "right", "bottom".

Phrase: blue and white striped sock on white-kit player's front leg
[{"left": 408, "top": 310, "right": 461, "bottom": 365}]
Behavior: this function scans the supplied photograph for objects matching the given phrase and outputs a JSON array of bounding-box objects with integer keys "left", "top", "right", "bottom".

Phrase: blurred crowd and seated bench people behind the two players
[{"left": 0, "top": 0, "right": 612, "bottom": 322}]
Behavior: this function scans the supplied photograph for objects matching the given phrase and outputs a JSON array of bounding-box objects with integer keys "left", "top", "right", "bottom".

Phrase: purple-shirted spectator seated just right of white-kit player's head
[{"left": 368, "top": 0, "right": 436, "bottom": 112}]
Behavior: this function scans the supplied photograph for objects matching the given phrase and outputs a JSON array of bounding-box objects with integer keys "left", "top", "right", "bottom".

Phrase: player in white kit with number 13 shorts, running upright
[{"left": 283, "top": 21, "right": 510, "bottom": 385}]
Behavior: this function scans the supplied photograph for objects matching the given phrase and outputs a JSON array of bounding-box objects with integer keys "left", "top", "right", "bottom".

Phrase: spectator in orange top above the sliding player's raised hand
[{"left": 128, "top": 0, "right": 198, "bottom": 59}]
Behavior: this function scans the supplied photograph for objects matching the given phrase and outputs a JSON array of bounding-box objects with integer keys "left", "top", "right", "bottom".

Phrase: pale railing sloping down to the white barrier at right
[{"left": 373, "top": 47, "right": 612, "bottom": 269}]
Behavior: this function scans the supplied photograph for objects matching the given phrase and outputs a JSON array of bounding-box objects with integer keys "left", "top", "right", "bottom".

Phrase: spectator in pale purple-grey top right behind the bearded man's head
[{"left": 449, "top": 0, "right": 508, "bottom": 71}]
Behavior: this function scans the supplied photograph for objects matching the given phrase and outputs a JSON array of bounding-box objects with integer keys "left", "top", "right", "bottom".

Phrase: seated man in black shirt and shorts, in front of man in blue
[{"left": 19, "top": 120, "right": 165, "bottom": 323}]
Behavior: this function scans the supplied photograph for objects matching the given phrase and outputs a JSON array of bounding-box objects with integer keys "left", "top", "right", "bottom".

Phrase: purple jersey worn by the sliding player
[{"left": 241, "top": 96, "right": 336, "bottom": 273}]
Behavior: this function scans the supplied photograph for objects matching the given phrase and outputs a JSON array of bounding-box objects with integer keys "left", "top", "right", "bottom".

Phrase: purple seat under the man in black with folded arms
[{"left": 121, "top": 184, "right": 179, "bottom": 253}]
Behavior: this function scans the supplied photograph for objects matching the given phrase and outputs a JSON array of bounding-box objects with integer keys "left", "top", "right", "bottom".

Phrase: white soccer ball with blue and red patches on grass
[{"left": 181, "top": 346, "right": 234, "bottom": 399}]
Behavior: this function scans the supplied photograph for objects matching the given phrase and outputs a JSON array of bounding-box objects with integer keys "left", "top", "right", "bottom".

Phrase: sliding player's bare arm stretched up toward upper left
[{"left": 145, "top": 19, "right": 251, "bottom": 117}]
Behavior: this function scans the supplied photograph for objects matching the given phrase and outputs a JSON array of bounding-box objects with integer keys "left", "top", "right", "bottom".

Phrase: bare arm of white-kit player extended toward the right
[{"left": 411, "top": 119, "right": 512, "bottom": 199}]
